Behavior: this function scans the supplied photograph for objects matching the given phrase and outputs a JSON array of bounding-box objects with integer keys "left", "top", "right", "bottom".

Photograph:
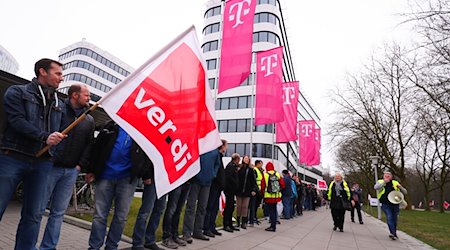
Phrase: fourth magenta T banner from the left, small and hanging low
[{"left": 299, "top": 120, "right": 316, "bottom": 166}]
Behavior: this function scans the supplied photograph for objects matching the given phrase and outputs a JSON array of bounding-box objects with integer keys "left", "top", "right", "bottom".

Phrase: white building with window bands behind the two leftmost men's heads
[{"left": 59, "top": 39, "right": 133, "bottom": 101}]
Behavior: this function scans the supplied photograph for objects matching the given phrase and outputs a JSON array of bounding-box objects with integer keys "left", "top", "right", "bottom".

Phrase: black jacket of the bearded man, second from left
[{"left": 53, "top": 99, "right": 95, "bottom": 171}]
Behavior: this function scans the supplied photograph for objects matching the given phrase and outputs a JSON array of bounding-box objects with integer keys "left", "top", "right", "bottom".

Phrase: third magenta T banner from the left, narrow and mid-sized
[{"left": 275, "top": 82, "right": 298, "bottom": 143}]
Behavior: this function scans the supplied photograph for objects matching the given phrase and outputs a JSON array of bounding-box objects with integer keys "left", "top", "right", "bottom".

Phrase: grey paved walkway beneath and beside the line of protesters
[{"left": 0, "top": 203, "right": 433, "bottom": 250}]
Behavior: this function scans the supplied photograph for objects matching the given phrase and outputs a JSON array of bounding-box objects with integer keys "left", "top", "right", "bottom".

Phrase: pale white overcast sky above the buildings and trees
[{"left": 0, "top": 0, "right": 410, "bottom": 172}]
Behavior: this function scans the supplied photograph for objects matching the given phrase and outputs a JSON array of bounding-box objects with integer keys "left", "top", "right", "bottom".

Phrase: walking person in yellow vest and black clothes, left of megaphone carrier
[{"left": 327, "top": 172, "right": 350, "bottom": 232}]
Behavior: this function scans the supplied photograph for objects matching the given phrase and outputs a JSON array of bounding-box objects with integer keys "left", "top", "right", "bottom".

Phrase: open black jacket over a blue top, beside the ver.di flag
[{"left": 87, "top": 121, "right": 154, "bottom": 180}]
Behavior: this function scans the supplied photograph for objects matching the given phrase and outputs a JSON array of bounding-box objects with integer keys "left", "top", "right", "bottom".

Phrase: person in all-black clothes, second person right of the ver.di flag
[{"left": 223, "top": 153, "right": 241, "bottom": 233}]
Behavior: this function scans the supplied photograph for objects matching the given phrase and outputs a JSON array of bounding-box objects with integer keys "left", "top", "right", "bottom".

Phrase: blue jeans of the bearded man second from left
[{"left": 40, "top": 166, "right": 79, "bottom": 250}]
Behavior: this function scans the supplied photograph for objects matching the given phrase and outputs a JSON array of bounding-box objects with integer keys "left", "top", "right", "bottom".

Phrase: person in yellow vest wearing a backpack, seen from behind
[{"left": 261, "top": 162, "right": 285, "bottom": 232}]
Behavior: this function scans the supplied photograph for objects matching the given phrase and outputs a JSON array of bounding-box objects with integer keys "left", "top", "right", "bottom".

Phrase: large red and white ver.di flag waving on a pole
[{"left": 100, "top": 27, "right": 221, "bottom": 197}]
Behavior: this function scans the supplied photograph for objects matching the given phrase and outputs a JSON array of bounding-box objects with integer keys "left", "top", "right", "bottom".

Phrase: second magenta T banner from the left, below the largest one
[{"left": 255, "top": 47, "right": 284, "bottom": 125}]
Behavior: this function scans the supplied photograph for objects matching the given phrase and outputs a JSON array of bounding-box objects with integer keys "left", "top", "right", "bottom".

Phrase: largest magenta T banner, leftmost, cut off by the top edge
[{"left": 218, "top": 0, "right": 256, "bottom": 93}]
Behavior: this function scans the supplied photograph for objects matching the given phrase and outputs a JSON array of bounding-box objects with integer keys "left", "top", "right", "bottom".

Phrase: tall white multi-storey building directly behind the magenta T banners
[{"left": 202, "top": 0, "right": 322, "bottom": 183}]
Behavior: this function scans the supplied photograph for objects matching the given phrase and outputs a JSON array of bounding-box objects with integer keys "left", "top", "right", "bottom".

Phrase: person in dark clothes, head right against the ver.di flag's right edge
[{"left": 203, "top": 139, "right": 228, "bottom": 237}]
